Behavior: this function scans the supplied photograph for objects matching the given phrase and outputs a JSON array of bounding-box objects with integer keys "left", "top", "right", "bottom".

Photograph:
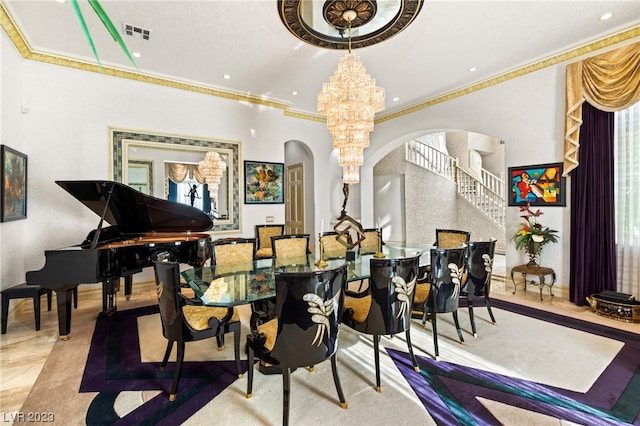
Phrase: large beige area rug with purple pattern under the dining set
[{"left": 17, "top": 300, "right": 640, "bottom": 425}]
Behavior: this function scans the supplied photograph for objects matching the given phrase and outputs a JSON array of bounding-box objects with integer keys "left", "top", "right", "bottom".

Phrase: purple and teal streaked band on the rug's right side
[{"left": 388, "top": 300, "right": 640, "bottom": 425}]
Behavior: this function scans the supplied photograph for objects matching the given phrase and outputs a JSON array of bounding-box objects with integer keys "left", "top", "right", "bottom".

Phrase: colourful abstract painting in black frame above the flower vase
[{"left": 507, "top": 163, "right": 566, "bottom": 207}]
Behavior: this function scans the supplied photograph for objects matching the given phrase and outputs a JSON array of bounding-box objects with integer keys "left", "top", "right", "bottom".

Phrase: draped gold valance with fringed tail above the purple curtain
[{"left": 564, "top": 43, "right": 640, "bottom": 176}]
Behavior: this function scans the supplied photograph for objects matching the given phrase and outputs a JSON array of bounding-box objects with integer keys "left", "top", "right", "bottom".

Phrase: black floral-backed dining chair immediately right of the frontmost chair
[{"left": 342, "top": 256, "right": 420, "bottom": 392}]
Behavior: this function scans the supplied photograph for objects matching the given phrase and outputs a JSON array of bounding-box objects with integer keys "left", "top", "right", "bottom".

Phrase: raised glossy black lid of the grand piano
[{"left": 56, "top": 180, "right": 213, "bottom": 233}]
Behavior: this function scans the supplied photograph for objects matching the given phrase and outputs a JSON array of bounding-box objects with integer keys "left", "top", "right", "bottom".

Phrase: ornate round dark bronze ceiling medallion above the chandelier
[{"left": 278, "top": 0, "right": 424, "bottom": 50}]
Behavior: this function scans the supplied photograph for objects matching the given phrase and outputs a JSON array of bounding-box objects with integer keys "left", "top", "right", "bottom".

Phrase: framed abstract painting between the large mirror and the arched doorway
[{"left": 244, "top": 161, "right": 284, "bottom": 204}]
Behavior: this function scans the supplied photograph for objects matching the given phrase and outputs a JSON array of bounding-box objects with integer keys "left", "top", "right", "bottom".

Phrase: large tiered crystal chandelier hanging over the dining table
[{"left": 318, "top": 9, "right": 384, "bottom": 184}]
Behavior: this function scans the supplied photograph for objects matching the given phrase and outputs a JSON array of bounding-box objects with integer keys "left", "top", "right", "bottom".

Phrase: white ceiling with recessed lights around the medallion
[{"left": 0, "top": 0, "right": 640, "bottom": 114}]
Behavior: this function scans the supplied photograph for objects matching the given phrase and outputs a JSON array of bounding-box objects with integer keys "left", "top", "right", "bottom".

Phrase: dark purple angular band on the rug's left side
[{"left": 80, "top": 305, "right": 246, "bottom": 425}]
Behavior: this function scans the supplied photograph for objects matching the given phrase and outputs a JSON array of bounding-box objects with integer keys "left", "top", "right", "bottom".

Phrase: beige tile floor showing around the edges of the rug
[{"left": 0, "top": 256, "right": 640, "bottom": 418}]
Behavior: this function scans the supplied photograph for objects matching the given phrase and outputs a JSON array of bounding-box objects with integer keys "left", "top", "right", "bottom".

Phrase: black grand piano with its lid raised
[{"left": 26, "top": 180, "right": 213, "bottom": 340}]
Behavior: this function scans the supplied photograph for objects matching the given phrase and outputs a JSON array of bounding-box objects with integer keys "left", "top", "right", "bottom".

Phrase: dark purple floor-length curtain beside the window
[{"left": 569, "top": 102, "right": 616, "bottom": 305}]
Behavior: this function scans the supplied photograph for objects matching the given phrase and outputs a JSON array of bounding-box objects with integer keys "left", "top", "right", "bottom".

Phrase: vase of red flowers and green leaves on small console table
[{"left": 511, "top": 203, "right": 559, "bottom": 266}]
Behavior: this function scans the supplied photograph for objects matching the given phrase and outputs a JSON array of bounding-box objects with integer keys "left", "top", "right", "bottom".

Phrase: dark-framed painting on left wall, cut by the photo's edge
[{"left": 0, "top": 145, "right": 27, "bottom": 222}]
